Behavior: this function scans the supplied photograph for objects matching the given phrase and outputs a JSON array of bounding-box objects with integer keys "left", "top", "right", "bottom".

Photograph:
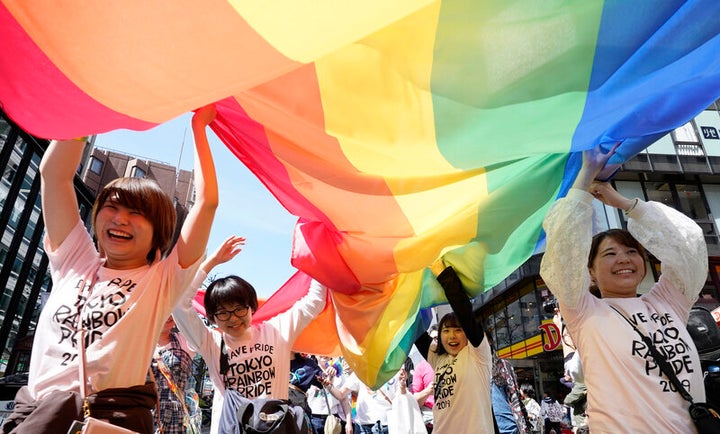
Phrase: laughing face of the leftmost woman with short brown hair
[{"left": 95, "top": 199, "right": 153, "bottom": 270}]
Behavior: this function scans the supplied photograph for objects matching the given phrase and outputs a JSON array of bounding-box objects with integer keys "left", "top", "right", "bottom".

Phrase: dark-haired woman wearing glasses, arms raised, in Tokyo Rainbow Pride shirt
[{"left": 173, "top": 236, "right": 327, "bottom": 434}]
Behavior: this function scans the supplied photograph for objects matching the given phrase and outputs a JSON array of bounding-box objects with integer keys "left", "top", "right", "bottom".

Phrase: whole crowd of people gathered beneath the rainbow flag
[{"left": 2, "top": 107, "right": 720, "bottom": 434}]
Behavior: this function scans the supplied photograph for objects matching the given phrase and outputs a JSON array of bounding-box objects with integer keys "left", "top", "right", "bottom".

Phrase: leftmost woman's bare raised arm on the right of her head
[{"left": 177, "top": 106, "right": 219, "bottom": 267}]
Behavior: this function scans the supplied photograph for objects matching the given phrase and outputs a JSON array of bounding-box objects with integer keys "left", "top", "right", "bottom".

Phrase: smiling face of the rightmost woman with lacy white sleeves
[{"left": 589, "top": 237, "right": 645, "bottom": 298}]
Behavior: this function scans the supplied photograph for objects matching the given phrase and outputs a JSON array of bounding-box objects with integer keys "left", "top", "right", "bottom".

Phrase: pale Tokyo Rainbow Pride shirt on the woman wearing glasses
[{"left": 173, "top": 270, "right": 327, "bottom": 434}]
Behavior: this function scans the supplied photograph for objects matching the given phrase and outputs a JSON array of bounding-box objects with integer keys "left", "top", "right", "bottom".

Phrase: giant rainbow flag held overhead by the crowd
[{"left": 0, "top": 0, "right": 720, "bottom": 386}]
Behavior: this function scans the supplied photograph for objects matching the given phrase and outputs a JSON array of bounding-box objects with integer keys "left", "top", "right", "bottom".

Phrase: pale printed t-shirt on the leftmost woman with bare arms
[{"left": 28, "top": 220, "right": 200, "bottom": 399}]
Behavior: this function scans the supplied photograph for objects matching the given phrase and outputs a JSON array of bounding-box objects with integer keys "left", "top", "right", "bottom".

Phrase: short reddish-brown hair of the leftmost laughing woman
[{"left": 92, "top": 177, "right": 177, "bottom": 264}]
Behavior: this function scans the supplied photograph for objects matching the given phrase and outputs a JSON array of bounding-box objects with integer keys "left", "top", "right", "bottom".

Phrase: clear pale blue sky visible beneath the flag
[{"left": 95, "top": 114, "right": 296, "bottom": 298}]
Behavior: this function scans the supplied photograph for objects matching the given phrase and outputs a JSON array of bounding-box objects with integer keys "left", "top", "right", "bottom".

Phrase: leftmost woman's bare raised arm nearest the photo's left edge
[{"left": 40, "top": 138, "right": 85, "bottom": 250}]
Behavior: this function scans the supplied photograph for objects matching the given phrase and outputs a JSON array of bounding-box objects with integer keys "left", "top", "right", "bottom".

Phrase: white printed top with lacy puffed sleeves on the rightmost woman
[{"left": 541, "top": 189, "right": 707, "bottom": 433}]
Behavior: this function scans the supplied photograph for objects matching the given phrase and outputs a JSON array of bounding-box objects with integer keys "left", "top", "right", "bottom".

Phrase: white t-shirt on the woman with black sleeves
[{"left": 428, "top": 339, "right": 495, "bottom": 434}]
